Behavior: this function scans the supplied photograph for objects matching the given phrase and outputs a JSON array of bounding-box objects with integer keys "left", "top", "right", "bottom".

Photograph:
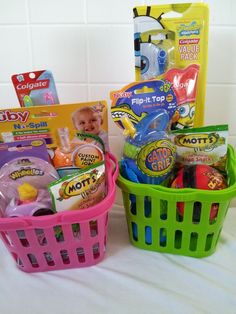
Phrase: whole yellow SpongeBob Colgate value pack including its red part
[{"left": 133, "top": 3, "right": 209, "bottom": 129}]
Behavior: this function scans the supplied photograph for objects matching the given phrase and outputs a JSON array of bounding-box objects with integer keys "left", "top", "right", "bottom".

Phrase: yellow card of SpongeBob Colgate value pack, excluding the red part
[{"left": 133, "top": 3, "right": 209, "bottom": 127}]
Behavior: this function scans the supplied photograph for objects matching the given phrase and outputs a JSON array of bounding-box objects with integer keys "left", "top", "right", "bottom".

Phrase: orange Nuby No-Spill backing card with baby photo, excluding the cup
[{"left": 0, "top": 101, "right": 108, "bottom": 150}]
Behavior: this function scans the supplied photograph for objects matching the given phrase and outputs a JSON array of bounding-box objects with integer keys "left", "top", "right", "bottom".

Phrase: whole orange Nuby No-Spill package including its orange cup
[{"left": 0, "top": 101, "right": 109, "bottom": 177}]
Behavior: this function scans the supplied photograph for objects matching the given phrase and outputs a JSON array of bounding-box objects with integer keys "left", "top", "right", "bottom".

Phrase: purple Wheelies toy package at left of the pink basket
[{"left": 0, "top": 140, "right": 58, "bottom": 217}]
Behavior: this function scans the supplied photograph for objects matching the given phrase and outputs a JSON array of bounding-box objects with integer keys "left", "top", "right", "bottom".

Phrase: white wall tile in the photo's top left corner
[{"left": 0, "top": 0, "right": 27, "bottom": 24}]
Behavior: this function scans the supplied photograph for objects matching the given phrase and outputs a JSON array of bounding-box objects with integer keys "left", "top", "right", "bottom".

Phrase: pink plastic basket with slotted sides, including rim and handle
[{"left": 0, "top": 153, "right": 118, "bottom": 272}]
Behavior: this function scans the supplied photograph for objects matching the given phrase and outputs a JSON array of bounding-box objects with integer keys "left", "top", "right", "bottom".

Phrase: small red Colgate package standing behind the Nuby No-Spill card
[{"left": 12, "top": 70, "right": 59, "bottom": 107}]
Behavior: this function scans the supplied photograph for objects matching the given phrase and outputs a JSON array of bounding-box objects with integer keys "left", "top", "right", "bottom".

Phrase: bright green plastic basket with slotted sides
[{"left": 117, "top": 145, "right": 236, "bottom": 257}]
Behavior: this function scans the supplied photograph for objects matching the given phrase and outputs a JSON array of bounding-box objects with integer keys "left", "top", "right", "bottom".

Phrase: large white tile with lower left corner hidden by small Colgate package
[{"left": 32, "top": 26, "right": 87, "bottom": 83}]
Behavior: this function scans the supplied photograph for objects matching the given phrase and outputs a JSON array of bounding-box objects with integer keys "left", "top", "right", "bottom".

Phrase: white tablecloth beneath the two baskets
[{"left": 0, "top": 207, "right": 236, "bottom": 314}]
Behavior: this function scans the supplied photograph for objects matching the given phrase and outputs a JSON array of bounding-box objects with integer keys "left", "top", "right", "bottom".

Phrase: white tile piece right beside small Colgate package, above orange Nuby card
[{"left": 56, "top": 84, "right": 88, "bottom": 104}]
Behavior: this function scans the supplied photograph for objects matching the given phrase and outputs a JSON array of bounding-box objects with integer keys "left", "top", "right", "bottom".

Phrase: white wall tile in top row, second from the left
[{"left": 29, "top": 0, "right": 85, "bottom": 23}]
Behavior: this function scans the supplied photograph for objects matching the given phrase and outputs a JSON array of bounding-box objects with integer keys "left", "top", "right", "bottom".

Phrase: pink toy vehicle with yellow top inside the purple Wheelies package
[{"left": 4, "top": 182, "right": 53, "bottom": 217}]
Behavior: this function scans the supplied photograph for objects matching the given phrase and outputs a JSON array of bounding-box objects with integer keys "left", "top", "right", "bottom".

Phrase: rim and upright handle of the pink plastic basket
[{"left": 0, "top": 152, "right": 119, "bottom": 231}]
